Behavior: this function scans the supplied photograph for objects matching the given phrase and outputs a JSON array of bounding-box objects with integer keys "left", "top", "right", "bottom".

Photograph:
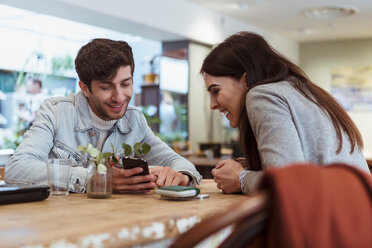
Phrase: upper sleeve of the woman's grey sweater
[{"left": 246, "top": 87, "right": 305, "bottom": 169}]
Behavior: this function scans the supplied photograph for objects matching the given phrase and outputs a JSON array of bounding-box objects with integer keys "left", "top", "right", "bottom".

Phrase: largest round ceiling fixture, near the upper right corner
[{"left": 303, "top": 6, "right": 359, "bottom": 20}]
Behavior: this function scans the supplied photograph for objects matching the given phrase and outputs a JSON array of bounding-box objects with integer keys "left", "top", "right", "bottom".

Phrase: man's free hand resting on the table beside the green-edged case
[{"left": 150, "top": 166, "right": 190, "bottom": 187}]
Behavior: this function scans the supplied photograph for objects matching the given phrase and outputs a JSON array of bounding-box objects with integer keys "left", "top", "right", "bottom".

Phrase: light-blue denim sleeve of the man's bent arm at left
[{"left": 5, "top": 101, "right": 87, "bottom": 193}]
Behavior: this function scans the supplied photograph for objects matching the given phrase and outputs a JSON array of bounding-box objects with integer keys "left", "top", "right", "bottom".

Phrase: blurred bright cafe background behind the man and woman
[{"left": 0, "top": 0, "right": 372, "bottom": 170}]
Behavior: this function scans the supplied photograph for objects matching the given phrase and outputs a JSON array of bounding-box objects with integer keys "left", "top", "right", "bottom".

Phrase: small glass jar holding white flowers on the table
[{"left": 77, "top": 144, "right": 118, "bottom": 198}]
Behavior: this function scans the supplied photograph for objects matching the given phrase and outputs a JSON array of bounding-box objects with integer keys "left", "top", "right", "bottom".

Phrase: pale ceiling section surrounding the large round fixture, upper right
[{"left": 184, "top": 0, "right": 372, "bottom": 42}]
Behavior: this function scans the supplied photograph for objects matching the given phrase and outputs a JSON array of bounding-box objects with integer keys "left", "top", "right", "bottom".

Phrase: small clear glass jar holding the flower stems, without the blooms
[{"left": 87, "top": 158, "right": 112, "bottom": 198}]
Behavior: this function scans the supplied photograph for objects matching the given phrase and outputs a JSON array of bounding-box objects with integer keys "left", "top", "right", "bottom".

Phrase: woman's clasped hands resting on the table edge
[{"left": 212, "top": 159, "right": 244, "bottom": 193}]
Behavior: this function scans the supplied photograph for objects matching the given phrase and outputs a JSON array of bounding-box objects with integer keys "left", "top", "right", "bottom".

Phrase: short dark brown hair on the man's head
[{"left": 75, "top": 39, "right": 134, "bottom": 89}]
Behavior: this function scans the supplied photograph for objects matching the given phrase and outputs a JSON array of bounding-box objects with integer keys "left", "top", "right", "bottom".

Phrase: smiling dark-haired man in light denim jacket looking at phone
[{"left": 6, "top": 39, "right": 201, "bottom": 193}]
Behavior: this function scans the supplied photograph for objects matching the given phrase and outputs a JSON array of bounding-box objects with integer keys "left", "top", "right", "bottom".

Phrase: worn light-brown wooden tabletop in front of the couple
[{"left": 0, "top": 180, "right": 247, "bottom": 247}]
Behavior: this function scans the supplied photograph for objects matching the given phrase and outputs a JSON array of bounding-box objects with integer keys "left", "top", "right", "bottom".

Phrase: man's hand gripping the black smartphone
[{"left": 112, "top": 167, "right": 156, "bottom": 194}]
